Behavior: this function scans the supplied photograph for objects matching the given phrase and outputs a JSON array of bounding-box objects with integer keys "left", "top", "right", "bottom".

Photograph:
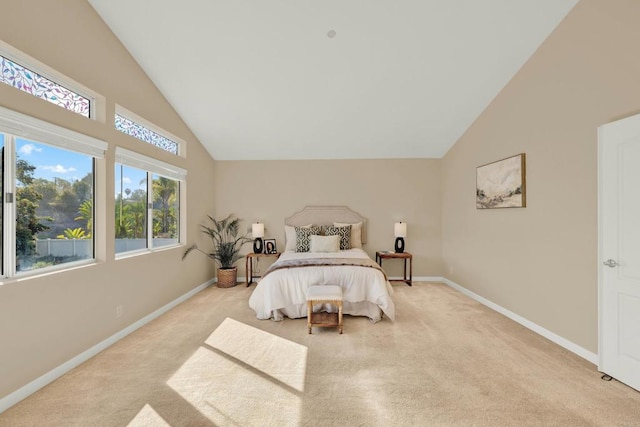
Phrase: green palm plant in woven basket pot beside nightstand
[{"left": 182, "top": 214, "right": 251, "bottom": 288}]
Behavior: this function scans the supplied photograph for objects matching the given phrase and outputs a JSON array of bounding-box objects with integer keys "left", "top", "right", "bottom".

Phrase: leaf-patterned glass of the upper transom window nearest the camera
[{"left": 0, "top": 56, "right": 91, "bottom": 118}]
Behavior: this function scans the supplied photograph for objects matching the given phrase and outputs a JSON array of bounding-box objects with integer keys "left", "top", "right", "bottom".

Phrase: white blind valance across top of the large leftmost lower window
[{"left": 0, "top": 107, "right": 107, "bottom": 159}]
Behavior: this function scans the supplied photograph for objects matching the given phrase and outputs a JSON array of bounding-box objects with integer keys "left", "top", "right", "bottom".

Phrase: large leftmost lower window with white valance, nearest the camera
[{"left": 0, "top": 108, "right": 106, "bottom": 277}]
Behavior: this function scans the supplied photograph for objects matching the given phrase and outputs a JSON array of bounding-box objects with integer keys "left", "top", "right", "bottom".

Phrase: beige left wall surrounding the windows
[{"left": 0, "top": 0, "right": 214, "bottom": 398}]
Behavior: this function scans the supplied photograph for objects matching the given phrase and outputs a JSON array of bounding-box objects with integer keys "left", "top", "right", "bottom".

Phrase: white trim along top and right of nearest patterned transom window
[{"left": 0, "top": 40, "right": 105, "bottom": 123}]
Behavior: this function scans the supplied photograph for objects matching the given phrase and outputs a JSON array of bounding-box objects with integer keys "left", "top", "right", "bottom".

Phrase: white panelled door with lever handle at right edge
[{"left": 598, "top": 115, "right": 640, "bottom": 390}]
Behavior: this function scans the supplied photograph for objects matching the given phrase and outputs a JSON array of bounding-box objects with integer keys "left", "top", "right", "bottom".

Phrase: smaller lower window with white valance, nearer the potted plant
[{"left": 115, "top": 147, "right": 186, "bottom": 254}]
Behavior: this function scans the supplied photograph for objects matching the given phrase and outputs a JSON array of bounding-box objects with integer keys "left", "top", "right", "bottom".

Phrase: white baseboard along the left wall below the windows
[{"left": 0, "top": 280, "right": 214, "bottom": 414}]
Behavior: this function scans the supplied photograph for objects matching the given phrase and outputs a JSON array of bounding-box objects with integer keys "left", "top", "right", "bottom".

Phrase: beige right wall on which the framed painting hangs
[{"left": 442, "top": 0, "right": 640, "bottom": 353}]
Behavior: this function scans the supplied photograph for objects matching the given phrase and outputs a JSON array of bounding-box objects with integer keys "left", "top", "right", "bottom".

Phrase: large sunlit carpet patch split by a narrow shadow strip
[{"left": 167, "top": 318, "right": 307, "bottom": 425}]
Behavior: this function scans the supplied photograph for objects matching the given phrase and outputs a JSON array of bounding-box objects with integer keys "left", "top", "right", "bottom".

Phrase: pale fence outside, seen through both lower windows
[{"left": 36, "top": 237, "right": 178, "bottom": 259}]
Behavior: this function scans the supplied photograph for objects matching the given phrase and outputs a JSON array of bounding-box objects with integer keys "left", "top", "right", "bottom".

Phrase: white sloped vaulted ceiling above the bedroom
[{"left": 89, "top": 0, "right": 577, "bottom": 160}]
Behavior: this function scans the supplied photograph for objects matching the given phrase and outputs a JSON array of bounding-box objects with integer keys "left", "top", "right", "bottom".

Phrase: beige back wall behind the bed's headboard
[{"left": 214, "top": 159, "right": 442, "bottom": 276}]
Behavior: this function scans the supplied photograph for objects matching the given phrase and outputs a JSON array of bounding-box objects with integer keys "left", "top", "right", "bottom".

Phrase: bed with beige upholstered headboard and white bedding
[{"left": 249, "top": 206, "right": 395, "bottom": 323}]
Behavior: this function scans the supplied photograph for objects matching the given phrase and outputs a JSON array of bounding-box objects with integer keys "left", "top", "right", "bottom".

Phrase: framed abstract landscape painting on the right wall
[{"left": 476, "top": 153, "right": 527, "bottom": 209}]
